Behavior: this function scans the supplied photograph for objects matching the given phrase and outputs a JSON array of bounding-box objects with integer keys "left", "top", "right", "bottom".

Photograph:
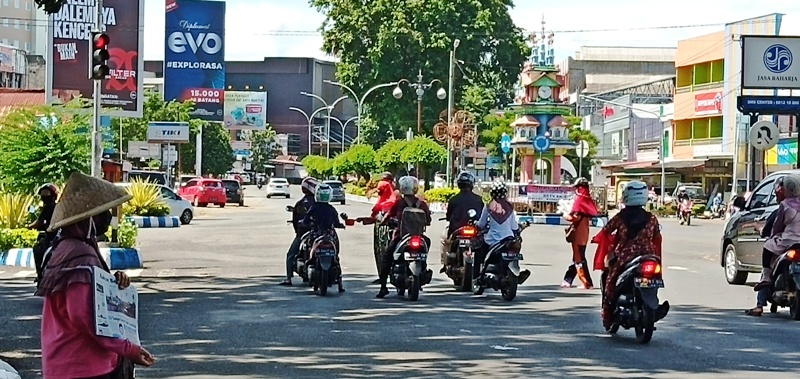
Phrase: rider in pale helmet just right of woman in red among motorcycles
[{"left": 376, "top": 176, "right": 432, "bottom": 299}]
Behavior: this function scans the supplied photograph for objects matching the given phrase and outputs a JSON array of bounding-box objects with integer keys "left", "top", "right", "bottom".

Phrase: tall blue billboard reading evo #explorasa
[{"left": 164, "top": 0, "right": 225, "bottom": 121}]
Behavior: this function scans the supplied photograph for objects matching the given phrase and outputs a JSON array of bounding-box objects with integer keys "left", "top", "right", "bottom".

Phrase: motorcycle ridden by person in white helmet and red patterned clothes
[{"left": 601, "top": 255, "right": 666, "bottom": 344}]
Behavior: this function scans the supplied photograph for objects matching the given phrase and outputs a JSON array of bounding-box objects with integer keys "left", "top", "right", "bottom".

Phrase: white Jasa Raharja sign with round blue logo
[{"left": 741, "top": 36, "right": 800, "bottom": 89}]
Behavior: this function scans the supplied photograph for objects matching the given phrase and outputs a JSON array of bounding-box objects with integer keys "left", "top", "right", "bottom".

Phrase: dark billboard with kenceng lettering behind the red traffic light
[{"left": 47, "top": 0, "right": 144, "bottom": 117}]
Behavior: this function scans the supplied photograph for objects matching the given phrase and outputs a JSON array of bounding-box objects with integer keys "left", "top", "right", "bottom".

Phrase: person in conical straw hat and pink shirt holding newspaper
[{"left": 36, "top": 172, "right": 155, "bottom": 378}]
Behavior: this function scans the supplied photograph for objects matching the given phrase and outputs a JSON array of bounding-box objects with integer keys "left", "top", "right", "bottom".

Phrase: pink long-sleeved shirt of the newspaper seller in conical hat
[{"left": 42, "top": 283, "right": 140, "bottom": 379}]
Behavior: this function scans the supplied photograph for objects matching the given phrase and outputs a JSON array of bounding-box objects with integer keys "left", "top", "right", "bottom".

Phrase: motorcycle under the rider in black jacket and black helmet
[{"left": 439, "top": 209, "right": 480, "bottom": 292}]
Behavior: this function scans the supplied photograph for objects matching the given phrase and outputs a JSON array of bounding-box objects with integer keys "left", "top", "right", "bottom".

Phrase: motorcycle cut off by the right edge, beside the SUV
[{"left": 767, "top": 244, "right": 800, "bottom": 320}]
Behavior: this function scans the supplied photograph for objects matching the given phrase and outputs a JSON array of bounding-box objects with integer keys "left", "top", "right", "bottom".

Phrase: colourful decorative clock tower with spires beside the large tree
[{"left": 511, "top": 16, "right": 576, "bottom": 184}]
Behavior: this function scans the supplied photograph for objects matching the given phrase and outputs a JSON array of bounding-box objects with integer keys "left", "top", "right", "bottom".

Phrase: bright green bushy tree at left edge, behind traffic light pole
[{"left": 0, "top": 106, "right": 91, "bottom": 193}]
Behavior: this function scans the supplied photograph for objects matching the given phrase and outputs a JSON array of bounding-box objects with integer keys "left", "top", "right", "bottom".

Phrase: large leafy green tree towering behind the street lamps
[{"left": 310, "top": 0, "right": 530, "bottom": 142}]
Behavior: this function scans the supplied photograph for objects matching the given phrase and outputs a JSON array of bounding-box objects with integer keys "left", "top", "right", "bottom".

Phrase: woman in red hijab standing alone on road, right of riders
[{"left": 561, "top": 178, "right": 598, "bottom": 289}]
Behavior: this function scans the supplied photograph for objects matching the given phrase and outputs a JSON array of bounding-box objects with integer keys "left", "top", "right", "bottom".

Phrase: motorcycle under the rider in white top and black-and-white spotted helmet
[{"left": 472, "top": 221, "right": 531, "bottom": 301}]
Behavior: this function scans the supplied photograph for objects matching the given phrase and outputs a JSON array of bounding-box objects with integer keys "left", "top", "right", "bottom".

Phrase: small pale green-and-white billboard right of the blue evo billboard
[{"left": 223, "top": 91, "right": 267, "bottom": 130}]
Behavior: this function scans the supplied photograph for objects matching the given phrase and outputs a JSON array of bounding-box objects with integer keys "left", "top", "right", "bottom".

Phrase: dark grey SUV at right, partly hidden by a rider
[{"left": 720, "top": 170, "right": 788, "bottom": 284}]
